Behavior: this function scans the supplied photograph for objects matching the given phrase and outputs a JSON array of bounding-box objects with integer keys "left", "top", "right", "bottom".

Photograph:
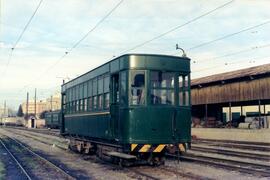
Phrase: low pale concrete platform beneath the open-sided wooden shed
[{"left": 191, "top": 128, "right": 270, "bottom": 143}]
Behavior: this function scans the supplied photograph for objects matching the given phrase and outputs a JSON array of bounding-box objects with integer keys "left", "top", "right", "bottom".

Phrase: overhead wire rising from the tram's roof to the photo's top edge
[{"left": 120, "top": 0, "right": 235, "bottom": 54}]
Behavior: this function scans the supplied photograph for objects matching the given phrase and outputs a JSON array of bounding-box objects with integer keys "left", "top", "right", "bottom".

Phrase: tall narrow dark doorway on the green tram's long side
[{"left": 110, "top": 74, "right": 120, "bottom": 140}]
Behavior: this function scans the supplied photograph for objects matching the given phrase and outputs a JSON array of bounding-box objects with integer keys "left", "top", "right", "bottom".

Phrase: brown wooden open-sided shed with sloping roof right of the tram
[{"left": 191, "top": 64, "right": 270, "bottom": 128}]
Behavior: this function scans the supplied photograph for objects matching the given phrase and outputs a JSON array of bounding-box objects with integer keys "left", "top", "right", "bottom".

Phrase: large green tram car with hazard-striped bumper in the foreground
[{"left": 61, "top": 54, "right": 191, "bottom": 163}]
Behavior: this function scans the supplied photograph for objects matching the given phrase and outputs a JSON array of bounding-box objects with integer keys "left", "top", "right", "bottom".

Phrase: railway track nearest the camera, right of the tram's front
[{"left": 167, "top": 154, "right": 270, "bottom": 177}]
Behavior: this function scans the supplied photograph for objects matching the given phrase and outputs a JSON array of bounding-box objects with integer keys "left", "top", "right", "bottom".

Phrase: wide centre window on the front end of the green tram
[{"left": 150, "top": 71, "right": 175, "bottom": 105}]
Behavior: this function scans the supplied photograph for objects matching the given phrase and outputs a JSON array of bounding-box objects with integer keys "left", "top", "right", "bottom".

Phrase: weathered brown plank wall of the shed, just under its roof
[{"left": 191, "top": 77, "right": 270, "bottom": 105}]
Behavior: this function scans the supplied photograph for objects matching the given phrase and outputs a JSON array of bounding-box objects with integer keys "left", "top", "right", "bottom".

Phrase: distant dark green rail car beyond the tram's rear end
[{"left": 45, "top": 110, "right": 62, "bottom": 129}]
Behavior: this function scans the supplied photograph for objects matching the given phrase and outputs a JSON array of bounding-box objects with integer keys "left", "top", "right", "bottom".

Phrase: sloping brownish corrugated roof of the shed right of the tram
[{"left": 191, "top": 64, "right": 270, "bottom": 86}]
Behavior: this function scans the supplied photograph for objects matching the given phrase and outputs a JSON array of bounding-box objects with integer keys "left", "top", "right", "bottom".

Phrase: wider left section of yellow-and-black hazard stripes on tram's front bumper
[{"left": 131, "top": 144, "right": 166, "bottom": 152}]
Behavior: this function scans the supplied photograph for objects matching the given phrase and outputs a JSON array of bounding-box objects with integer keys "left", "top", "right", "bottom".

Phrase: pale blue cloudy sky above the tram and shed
[{"left": 0, "top": 0, "right": 270, "bottom": 109}]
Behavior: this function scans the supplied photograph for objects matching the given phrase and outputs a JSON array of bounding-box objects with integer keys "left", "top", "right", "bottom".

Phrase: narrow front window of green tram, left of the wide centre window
[{"left": 129, "top": 71, "right": 145, "bottom": 105}]
